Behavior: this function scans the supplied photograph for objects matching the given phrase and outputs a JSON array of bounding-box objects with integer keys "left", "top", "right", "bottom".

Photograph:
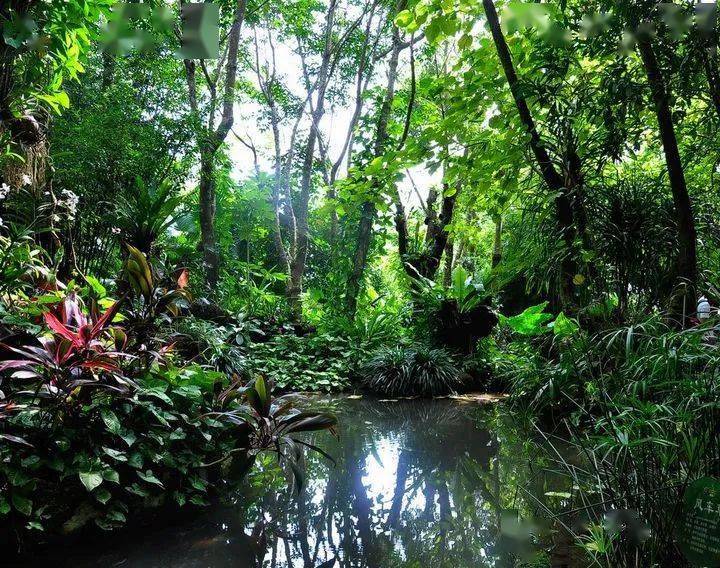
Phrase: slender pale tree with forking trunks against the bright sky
[{"left": 254, "top": 0, "right": 376, "bottom": 320}]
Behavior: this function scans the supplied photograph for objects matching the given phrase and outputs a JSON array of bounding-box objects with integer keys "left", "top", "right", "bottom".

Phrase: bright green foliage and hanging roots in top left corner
[{"left": 0, "top": 0, "right": 113, "bottom": 190}]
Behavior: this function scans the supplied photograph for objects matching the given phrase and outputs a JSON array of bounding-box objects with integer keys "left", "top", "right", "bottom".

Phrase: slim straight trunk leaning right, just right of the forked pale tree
[{"left": 345, "top": 0, "right": 406, "bottom": 317}]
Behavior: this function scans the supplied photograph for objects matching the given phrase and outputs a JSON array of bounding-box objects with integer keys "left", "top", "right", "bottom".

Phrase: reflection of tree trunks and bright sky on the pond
[{"left": 246, "top": 400, "right": 506, "bottom": 568}]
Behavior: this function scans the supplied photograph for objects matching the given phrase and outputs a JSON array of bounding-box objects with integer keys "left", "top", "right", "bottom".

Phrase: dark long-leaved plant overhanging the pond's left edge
[{"left": 213, "top": 376, "right": 337, "bottom": 491}]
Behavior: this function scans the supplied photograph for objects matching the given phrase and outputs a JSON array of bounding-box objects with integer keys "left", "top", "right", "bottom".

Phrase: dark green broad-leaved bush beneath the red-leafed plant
[{"left": 0, "top": 368, "right": 238, "bottom": 532}]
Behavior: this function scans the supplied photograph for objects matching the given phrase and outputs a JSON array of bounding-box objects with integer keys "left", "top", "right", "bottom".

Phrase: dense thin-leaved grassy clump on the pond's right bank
[{"left": 505, "top": 315, "right": 720, "bottom": 566}]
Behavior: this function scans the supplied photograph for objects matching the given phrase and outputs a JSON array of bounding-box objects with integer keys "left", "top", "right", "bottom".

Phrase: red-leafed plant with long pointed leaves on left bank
[{"left": 0, "top": 294, "right": 131, "bottom": 396}]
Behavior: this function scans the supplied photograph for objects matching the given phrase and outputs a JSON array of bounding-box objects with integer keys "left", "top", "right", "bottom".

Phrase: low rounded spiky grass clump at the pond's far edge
[{"left": 362, "top": 346, "right": 461, "bottom": 397}]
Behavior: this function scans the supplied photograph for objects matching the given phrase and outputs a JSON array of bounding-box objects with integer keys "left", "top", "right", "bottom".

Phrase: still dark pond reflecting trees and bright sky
[{"left": 15, "top": 398, "right": 572, "bottom": 568}]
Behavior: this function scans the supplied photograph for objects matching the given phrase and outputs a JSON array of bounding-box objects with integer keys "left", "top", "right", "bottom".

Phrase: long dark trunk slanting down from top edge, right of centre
[{"left": 483, "top": 0, "right": 575, "bottom": 307}]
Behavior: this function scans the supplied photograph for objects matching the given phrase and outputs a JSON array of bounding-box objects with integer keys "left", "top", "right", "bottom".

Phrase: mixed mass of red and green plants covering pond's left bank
[{"left": 0, "top": 247, "right": 335, "bottom": 546}]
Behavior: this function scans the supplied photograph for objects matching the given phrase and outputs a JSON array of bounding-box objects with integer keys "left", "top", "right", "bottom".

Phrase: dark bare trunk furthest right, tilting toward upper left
[{"left": 637, "top": 36, "right": 697, "bottom": 325}]
